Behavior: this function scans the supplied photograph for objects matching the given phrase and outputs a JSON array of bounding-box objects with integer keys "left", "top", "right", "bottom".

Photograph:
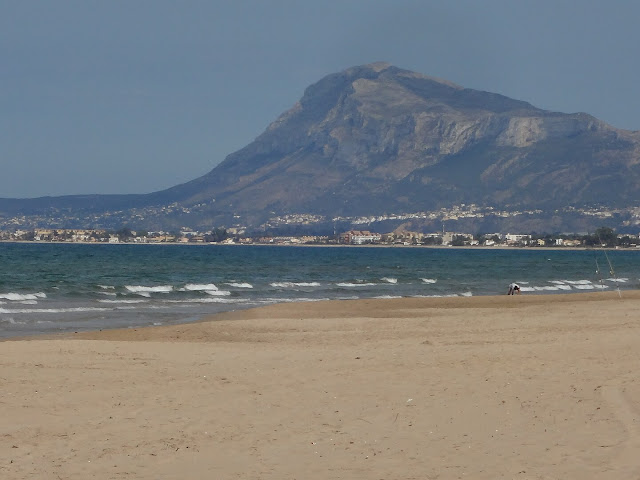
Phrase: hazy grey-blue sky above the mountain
[{"left": 0, "top": 0, "right": 640, "bottom": 197}]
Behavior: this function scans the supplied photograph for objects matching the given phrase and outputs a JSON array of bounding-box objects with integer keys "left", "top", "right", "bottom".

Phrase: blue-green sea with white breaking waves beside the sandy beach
[{"left": 0, "top": 243, "right": 640, "bottom": 338}]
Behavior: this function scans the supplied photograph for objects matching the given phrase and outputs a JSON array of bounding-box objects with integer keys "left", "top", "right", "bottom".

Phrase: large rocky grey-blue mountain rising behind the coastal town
[{"left": 0, "top": 63, "right": 640, "bottom": 232}]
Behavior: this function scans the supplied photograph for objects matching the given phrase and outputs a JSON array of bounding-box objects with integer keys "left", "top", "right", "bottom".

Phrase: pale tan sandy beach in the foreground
[{"left": 0, "top": 292, "right": 640, "bottom": 480}]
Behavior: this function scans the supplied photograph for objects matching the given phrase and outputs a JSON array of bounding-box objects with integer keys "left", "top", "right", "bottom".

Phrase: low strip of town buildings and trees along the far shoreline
[{"left": 0, "top": 227, "right": 640, "bottom": 248}]
